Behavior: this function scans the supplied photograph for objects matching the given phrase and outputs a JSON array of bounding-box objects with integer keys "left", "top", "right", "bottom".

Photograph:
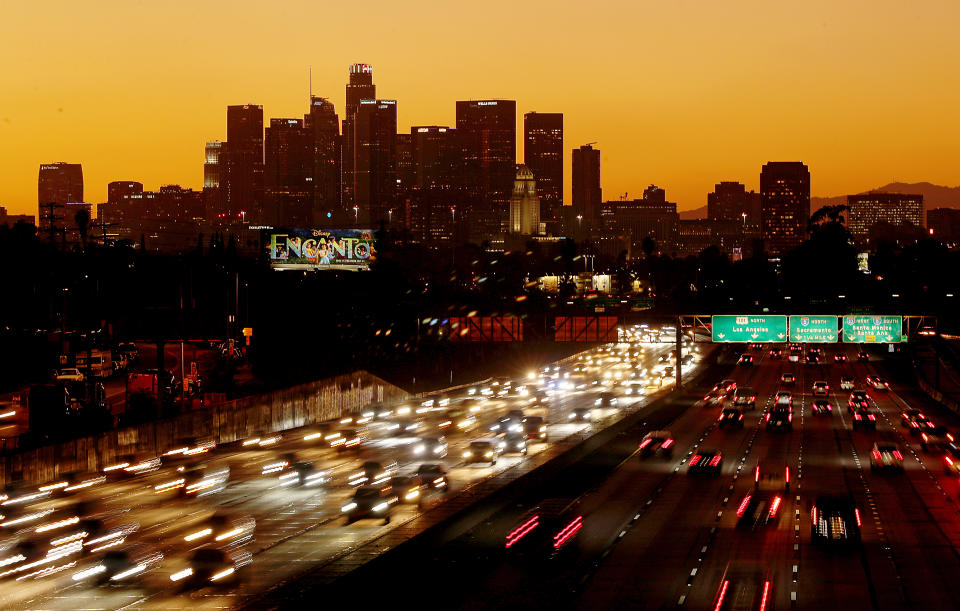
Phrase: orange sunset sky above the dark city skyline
[{"left": 0, "top": 0, "right": 960, "bottom": 214}]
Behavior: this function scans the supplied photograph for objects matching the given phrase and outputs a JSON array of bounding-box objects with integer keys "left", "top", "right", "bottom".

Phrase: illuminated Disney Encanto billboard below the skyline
[{"left": 266, "top": 229, "right": 377, "bottom": 270}]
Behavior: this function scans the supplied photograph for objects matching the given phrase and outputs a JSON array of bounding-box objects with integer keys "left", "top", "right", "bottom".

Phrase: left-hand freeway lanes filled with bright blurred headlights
[{"left": 0, "top": 332, "right": 695, "bottom": 609}]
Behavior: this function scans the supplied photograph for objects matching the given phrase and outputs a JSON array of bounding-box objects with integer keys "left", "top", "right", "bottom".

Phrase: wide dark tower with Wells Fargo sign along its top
[{"left": 457, "top": 100, "right": 517, "bottom": 240}]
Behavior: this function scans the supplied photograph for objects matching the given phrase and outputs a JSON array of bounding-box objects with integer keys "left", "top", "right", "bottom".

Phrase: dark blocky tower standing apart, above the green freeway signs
[{"left": 760, "top": 161, "right": 810, "bottom": 255}]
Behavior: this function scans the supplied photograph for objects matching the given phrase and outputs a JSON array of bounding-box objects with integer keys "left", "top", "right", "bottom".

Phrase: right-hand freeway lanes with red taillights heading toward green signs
[{"left": 356, "top": 345, "right": 960, "bottom": 609}]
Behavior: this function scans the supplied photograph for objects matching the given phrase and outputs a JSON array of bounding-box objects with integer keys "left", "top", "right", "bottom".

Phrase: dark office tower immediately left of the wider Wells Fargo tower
[{"left": 409, "top": 125, "right": 461, "bottom": 242}]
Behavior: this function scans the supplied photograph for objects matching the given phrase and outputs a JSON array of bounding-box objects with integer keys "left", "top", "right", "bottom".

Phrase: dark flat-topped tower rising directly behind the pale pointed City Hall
[{"left": 523, "top": 112, "right": 563, "bottom": 220}]
